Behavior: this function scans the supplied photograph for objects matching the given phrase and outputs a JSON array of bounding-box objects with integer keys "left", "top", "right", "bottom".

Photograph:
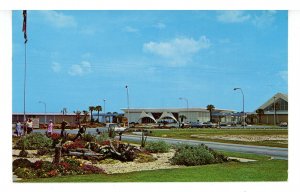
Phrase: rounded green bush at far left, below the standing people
[{"left": 15, "top": 133, "right": 52, "bottom": 149}]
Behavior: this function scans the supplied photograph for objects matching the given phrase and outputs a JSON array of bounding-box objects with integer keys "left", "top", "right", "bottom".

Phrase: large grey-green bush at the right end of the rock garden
[{"left": 171, "top": 145, "right": 221, "bottom": 166}]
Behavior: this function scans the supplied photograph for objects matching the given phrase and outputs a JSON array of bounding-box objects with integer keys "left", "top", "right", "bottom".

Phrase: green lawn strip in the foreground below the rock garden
[{"left": 22, "top": 160, "right": 288, "bottom": 182}]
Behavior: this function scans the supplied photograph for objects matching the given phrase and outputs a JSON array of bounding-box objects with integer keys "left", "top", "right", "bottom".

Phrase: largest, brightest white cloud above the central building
[{"left": 143, "top": 36, "right": 211, "bottom": 65}]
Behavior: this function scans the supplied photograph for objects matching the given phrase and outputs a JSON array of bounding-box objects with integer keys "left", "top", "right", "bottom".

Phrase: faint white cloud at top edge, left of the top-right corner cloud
[{"left": 217, "top": 11, "right": 251, "bottom": 23}]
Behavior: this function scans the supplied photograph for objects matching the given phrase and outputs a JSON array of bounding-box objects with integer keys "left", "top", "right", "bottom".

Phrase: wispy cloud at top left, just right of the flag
[{"left": 40, "top": 11, "right": 77, "bottom": 28}]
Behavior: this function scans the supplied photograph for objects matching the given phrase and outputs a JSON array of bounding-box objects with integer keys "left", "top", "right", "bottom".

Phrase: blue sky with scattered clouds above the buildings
[{"left": 12, "top": 11, "right": 288, "bottom": 112}]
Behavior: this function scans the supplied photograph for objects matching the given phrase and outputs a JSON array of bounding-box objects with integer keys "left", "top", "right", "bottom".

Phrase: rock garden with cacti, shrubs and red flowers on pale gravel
[{"left": 12, "top": 130, "right": 230, "bottom": 179}]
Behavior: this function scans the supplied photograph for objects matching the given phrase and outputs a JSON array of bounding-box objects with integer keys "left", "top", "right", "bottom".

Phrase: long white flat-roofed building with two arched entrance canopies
[{"left": 121, "top": 108, "right": 233, "bottom": 123}]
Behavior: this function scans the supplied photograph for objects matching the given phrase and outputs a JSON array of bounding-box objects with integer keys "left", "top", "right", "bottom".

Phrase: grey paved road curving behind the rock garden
[{"left": 122, "top": 135, "right": 288, "bottom": 160}]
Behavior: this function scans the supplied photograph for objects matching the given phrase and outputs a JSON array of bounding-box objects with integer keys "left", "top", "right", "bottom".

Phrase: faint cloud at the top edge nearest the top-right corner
[{"left": 252, "top": 11, "right": 276, "bottom": 28}]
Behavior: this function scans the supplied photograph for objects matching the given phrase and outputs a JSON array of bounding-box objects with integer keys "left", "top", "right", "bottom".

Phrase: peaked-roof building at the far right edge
[{"left": 256, "top": 93, "right": 288, "bottom": 125}]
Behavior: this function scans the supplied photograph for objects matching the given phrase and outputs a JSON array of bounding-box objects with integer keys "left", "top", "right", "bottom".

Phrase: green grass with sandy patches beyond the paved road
[{"left": 144, "top": 129, "right": 288, "bottom": 148}]
